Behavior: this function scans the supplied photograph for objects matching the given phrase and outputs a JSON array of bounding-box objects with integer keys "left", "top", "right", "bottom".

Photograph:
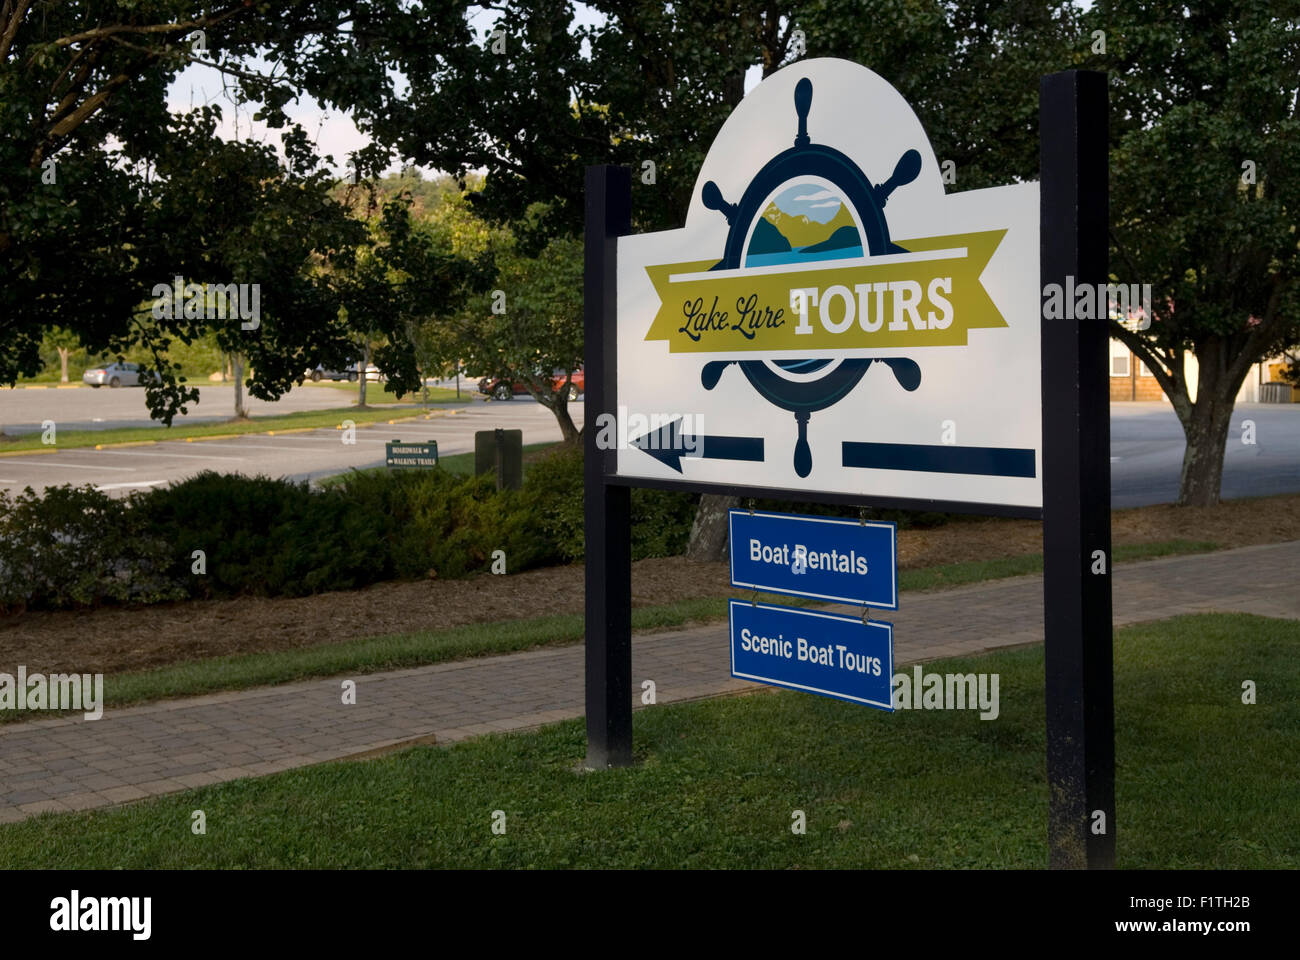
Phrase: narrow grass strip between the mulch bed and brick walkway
[{"left": 0, "top": 535, "right": 1216, "bottom": 726}]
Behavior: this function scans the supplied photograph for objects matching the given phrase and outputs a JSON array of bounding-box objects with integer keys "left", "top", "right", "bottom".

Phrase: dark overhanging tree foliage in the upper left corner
[{"left": 0, "top": 0, "right": 399, "bottom": 421}]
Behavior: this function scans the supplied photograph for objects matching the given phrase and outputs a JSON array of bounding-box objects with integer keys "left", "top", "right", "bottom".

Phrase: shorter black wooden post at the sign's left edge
[{"left": 582, "top": 167, "right": 632, "bottom": 769}]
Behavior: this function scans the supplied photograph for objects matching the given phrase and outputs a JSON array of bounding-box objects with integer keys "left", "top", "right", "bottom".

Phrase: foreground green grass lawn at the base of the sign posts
[{"left": 0, "top": 614, "right": 1300, "bottom": 869}]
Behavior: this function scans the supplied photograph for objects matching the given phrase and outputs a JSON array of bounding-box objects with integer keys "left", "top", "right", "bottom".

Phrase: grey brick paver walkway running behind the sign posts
[{"left": 0, "top": 541, "right": 1300, "bottom": 822}]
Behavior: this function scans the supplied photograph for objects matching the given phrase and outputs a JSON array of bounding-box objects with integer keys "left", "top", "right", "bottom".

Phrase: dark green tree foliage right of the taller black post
[{"left": 1087, "top": 0, "right": 1300, "bottom": 364}]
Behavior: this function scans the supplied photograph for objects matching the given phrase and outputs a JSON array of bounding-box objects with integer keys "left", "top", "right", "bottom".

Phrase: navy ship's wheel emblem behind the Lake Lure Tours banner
[{"left": 701, "top": 77, "right": 920, "bottom": 477}]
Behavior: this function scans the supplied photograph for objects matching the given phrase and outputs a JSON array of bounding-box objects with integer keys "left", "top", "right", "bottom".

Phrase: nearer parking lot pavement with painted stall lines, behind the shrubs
[{"left": 0, "top": 402, "right": 582, "bottom": 494}]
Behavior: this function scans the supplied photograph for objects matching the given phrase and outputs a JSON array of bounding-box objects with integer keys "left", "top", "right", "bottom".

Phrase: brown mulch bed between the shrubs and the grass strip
[{"left": 0, "top": 496, "right": 1300, "bottom": 674}]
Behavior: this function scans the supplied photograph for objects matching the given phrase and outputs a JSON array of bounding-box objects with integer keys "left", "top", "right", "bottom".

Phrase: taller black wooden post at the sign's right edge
[{"left": 1039, "top": 70, "right": 1115, "bottom": 868}]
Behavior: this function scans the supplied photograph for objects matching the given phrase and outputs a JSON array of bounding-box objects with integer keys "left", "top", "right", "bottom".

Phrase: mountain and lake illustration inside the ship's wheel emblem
[{"left": 745, "top": 181, "right": 863, "bottom": 267}]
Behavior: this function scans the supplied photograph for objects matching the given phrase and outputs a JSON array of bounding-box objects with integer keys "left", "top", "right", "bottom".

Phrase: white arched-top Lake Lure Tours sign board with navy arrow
[{"left": 607, "top": 60, "right": 1043, "bottom": 507}]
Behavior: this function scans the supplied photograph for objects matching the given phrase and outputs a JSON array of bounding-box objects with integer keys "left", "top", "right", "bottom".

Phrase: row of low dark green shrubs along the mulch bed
[{"left": 0, "top": 445, "right": 946, "bottom": 610}]
